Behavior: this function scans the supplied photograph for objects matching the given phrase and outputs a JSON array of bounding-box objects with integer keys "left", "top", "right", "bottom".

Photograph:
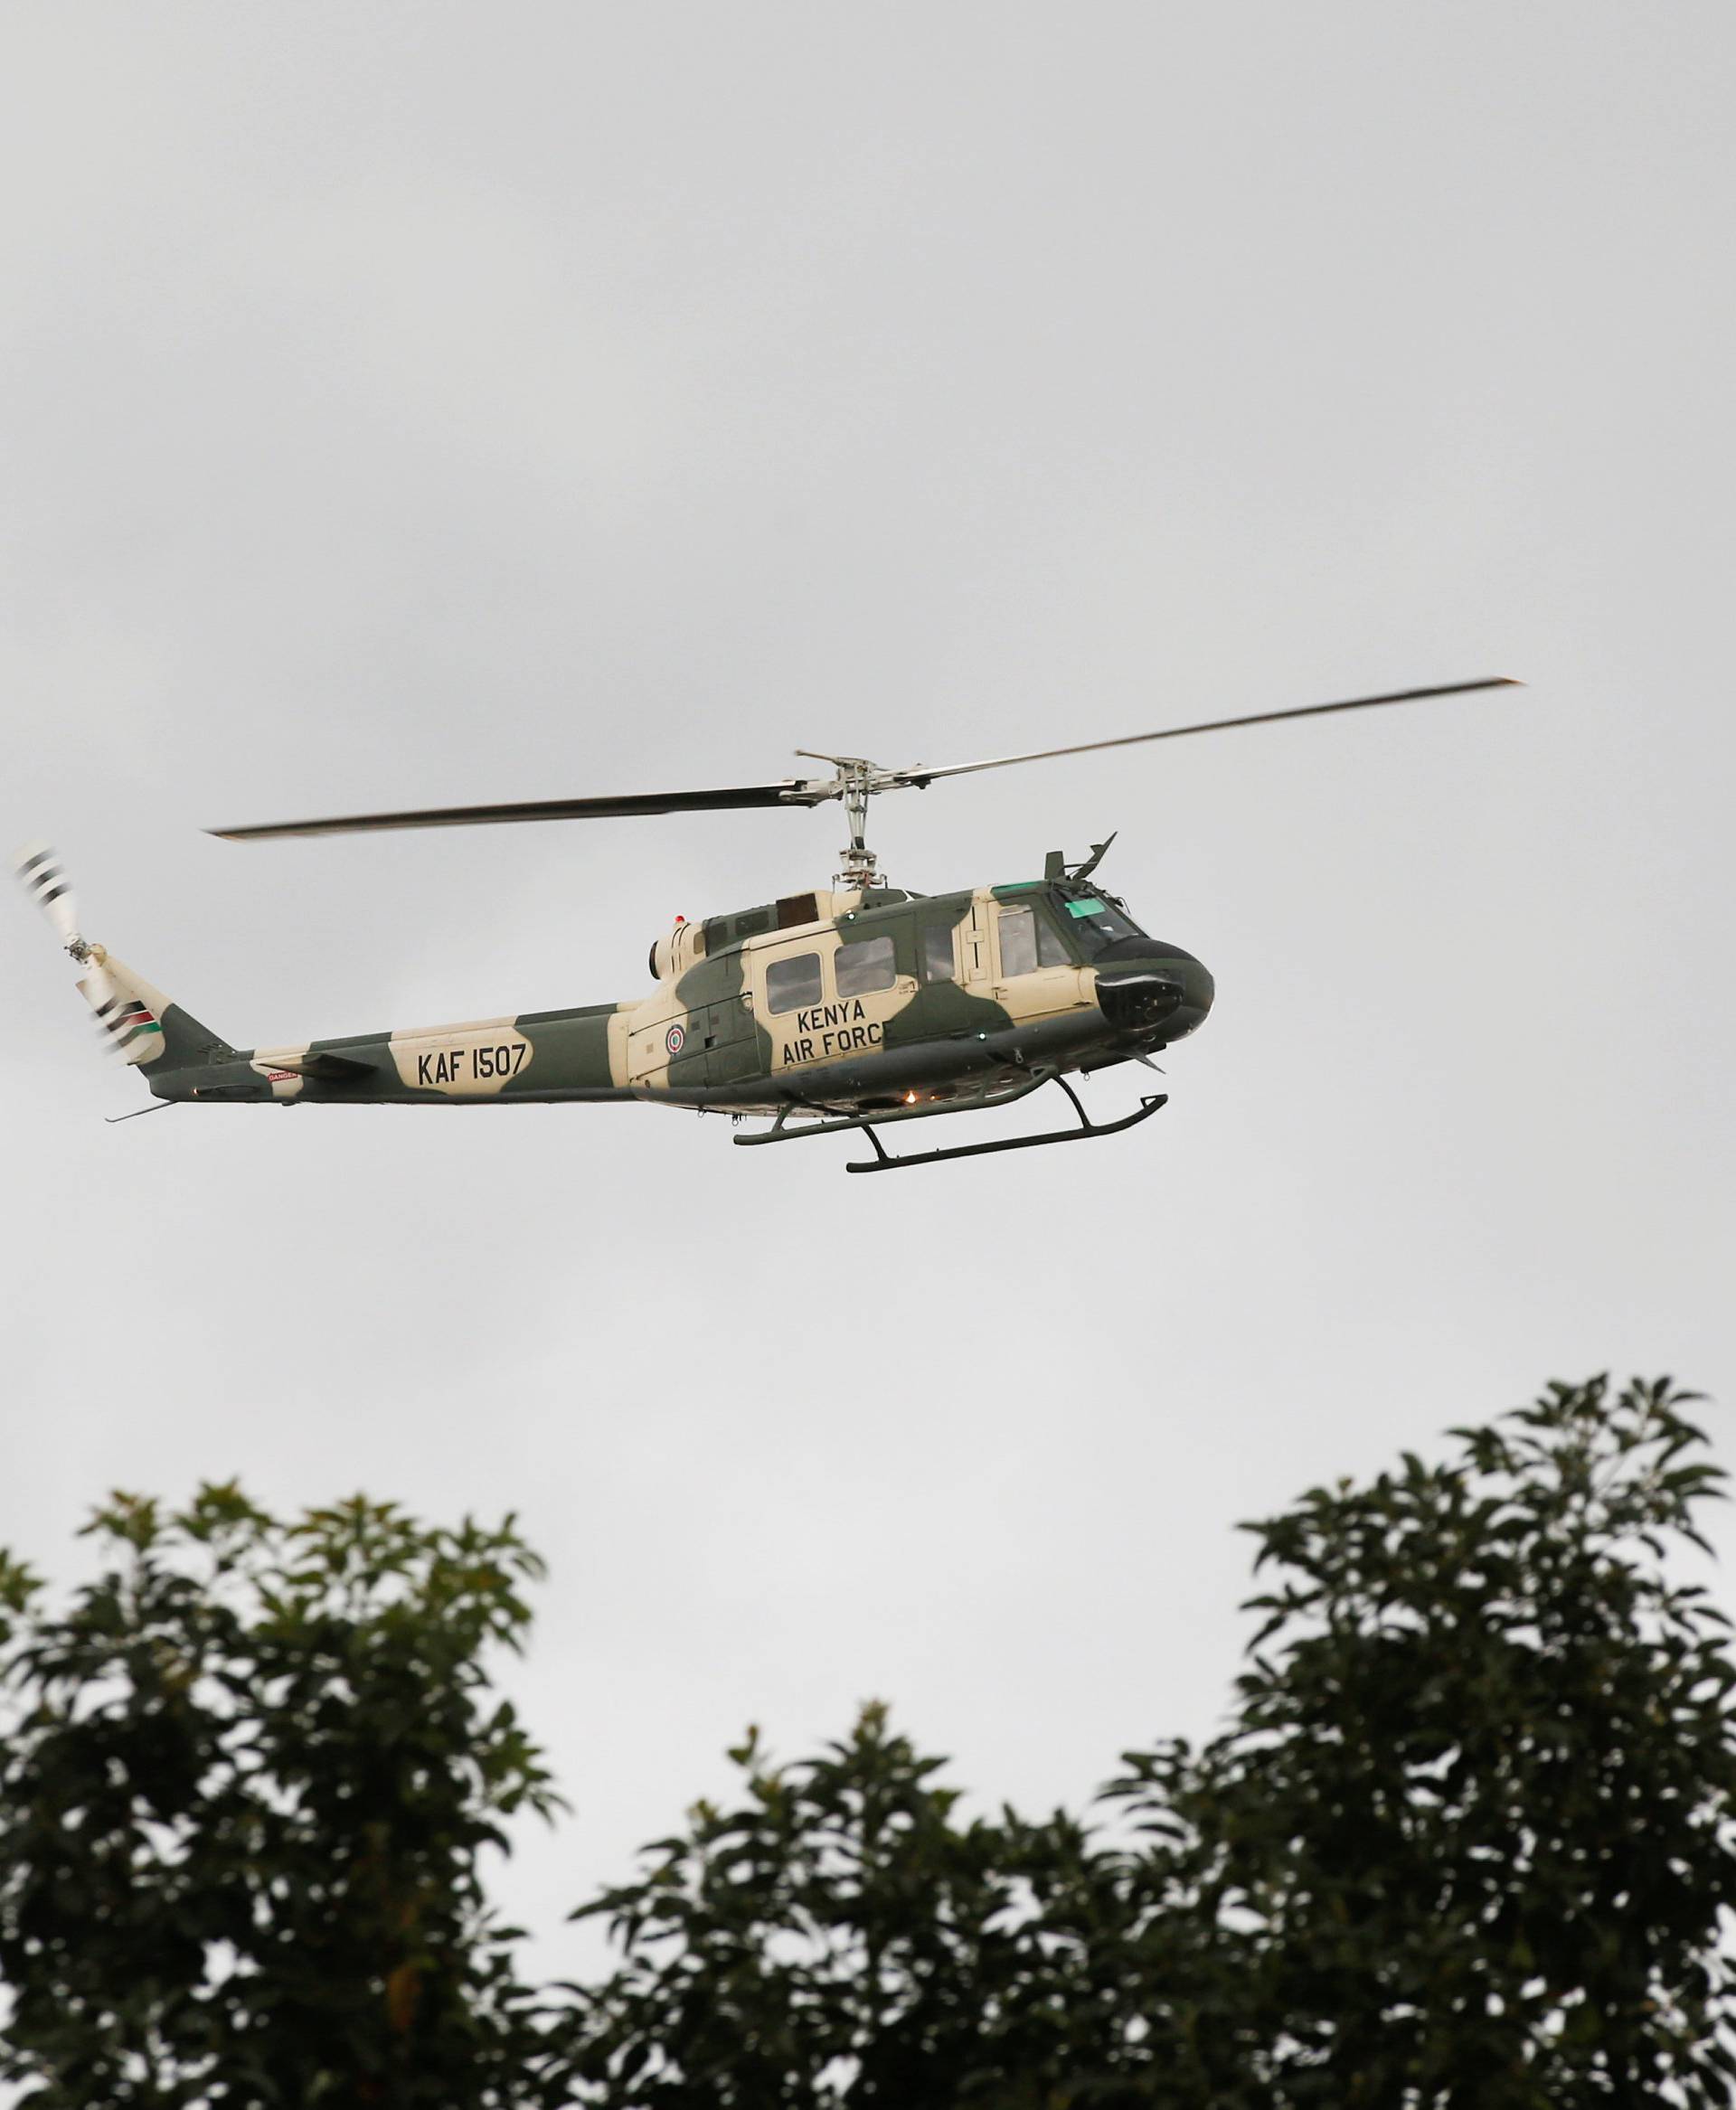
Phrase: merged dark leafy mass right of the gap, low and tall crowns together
[{"left": 574, "top": 1378, "right": 1736, "bottom": 2110}]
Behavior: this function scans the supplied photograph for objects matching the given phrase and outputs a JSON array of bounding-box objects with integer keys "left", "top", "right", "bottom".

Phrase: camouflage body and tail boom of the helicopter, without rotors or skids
[{"left": 149, "top": 878, "right": 1212, "bottom": 1116}]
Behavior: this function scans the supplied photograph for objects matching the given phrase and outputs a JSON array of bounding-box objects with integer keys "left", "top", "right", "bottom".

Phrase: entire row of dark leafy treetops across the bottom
[{"left": 0, "top": 1378, "right": 1736, "bottom": 2110}]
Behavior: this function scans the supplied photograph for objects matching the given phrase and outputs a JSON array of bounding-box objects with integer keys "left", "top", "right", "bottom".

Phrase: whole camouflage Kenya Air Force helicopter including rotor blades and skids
[{"left": 19, "top": 677, "right": 1514, "bottom": 1173}]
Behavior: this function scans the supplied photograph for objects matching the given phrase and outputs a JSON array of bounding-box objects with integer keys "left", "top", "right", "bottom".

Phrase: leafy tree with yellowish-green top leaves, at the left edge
[{"left": 0, "top": 1485, "right": 555, "bottom": 2110}]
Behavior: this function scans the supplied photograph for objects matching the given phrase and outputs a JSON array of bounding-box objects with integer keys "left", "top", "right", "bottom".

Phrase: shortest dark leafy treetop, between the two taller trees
[{"left": 576, "top": 1705, "right": 1164, "bottom": 2110}]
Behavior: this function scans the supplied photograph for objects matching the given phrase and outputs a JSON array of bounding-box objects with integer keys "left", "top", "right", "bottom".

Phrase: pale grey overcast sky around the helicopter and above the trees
[{"left": 0, "top": 0, "right": 1736, "bottom": 1969}]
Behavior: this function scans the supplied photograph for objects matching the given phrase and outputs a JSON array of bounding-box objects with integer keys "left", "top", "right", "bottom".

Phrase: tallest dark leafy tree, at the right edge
[{"left": 1109, "top": 1378, "right": 1736, "bottom": 2110}]
